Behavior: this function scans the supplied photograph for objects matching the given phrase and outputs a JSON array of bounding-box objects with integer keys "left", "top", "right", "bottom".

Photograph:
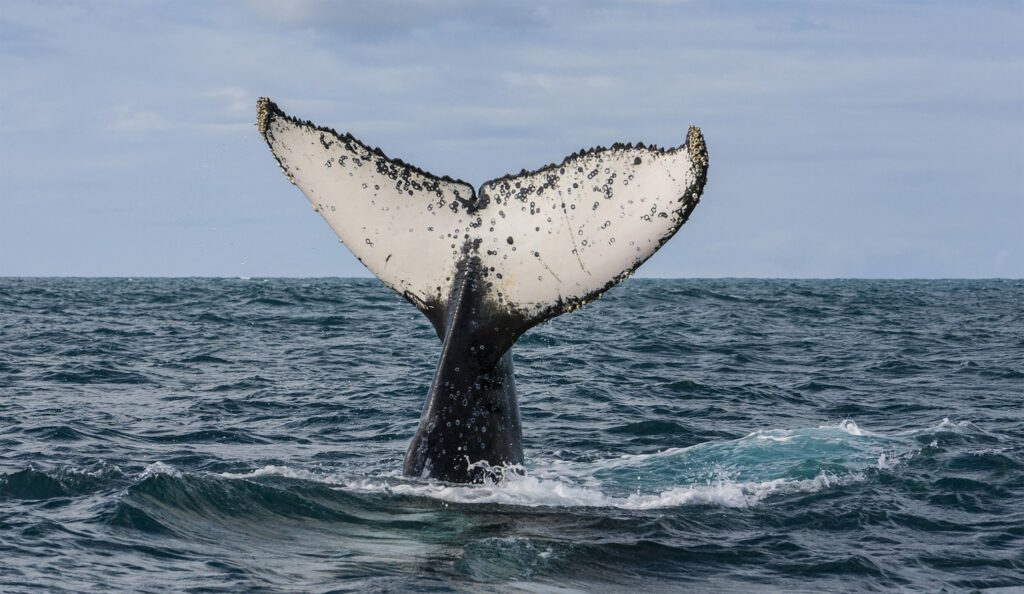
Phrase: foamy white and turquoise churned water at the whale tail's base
[{"left": 220, "top": 420, "right": 915, "bottom": 510}]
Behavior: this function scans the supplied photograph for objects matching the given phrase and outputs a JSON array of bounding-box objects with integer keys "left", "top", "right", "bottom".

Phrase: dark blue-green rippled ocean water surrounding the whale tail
[{"left": 0, "top": 279, "right": 1024, "bottom": 592}]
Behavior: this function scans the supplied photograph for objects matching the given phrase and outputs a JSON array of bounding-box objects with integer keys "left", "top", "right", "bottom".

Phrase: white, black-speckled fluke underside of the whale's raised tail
[{"left": 258, "top": 99, "right": 708, "bottom": 317}]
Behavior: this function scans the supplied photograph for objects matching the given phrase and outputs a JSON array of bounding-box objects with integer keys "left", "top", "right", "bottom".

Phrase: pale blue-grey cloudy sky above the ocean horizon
[{"left": 0, "top": 0, "right": 1024, "bottom": 278}]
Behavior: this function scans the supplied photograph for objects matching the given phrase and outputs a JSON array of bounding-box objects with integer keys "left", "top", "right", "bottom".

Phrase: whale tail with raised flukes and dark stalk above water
[{"left": 256, "top": 97, "right": 708, "bottom": 482}]
